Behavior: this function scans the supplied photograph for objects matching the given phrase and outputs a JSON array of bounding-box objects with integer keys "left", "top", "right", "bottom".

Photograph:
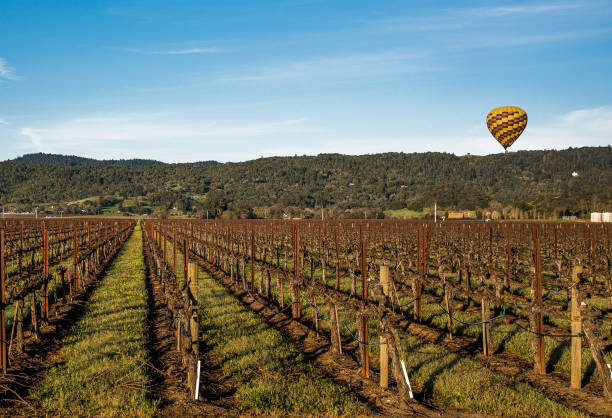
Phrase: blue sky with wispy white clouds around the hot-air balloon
[{"left": 0, "top": 0, "right": 612, "bottom": 162}]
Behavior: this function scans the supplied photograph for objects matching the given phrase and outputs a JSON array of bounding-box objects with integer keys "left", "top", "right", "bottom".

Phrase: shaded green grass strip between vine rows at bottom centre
[{"left": 199, "top": 270, "right": 366, "bottom": 415}]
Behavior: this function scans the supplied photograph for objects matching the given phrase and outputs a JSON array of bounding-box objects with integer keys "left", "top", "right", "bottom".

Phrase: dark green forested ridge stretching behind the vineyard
[{"left": 0, "top": 146, "right": 612, "bottom": 216}]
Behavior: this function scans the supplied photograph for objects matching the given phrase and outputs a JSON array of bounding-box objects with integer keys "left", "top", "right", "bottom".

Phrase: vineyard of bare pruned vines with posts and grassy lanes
[{"left": 0, "top": 219, "right": 612, "bottom": 416}]
